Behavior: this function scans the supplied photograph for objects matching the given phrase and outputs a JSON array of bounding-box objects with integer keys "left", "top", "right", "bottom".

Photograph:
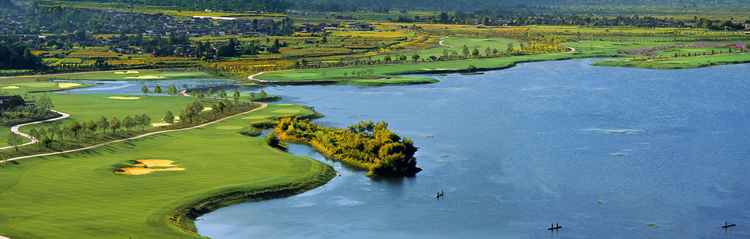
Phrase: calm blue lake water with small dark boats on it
[{"left": 66, "top": 59, "right": 750, "bottom": 238}]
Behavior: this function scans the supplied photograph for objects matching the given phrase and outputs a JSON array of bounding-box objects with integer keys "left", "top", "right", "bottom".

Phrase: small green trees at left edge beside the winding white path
[{"left": 0, "top": 94, "right": 57, "bottom": 125}]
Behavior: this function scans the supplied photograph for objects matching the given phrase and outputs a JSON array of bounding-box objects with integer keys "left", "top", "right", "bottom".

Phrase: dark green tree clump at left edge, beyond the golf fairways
[{"left": 0, "top": 39, "right": 44, "bottom": 69}]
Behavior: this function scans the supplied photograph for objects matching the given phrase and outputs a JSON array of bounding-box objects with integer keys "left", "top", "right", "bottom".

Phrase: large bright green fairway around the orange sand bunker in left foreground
[{"left": 0, "top": 102, "right": 334, "bottom": 238}]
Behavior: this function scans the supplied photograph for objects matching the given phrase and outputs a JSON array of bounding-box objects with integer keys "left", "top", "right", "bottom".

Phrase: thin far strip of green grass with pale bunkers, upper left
[{"left": 0, "top": 70, "right": 211, "bottom": 81}]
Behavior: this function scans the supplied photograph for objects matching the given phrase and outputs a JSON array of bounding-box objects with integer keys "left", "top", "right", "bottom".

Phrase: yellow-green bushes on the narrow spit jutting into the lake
[{"left": 274, "top": 118, "right": 421, "bottom": 175}]
